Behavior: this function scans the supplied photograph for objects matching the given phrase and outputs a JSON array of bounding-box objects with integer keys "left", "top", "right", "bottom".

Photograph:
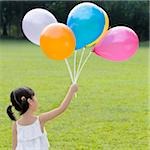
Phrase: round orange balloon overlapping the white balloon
[{"left": 40, "top": 23, "right": 76, "bottom": 60}]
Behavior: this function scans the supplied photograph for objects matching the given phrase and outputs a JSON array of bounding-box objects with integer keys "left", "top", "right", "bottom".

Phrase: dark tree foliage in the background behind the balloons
[{"left": 0, "top": 1, "right": 149, "bottom": 40}]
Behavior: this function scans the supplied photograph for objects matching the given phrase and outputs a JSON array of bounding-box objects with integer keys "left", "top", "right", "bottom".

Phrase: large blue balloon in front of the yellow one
[{"left": 67, "top": 2, "right": 105, "bottom": 50}]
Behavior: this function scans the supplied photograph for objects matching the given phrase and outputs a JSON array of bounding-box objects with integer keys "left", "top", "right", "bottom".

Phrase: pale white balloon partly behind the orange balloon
[{"left": 22, "top": 8, "right": 57, "bottom": 45}]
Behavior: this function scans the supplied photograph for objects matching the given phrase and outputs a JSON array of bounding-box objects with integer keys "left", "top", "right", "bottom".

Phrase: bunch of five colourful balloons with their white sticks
[{"left": 22, "top": 2, "right": 139, "bottom": 91}]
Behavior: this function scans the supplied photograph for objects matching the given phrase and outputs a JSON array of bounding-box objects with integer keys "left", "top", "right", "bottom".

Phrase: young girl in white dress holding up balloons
[{"left": 7, "top": 84, "right": 78, "bottom": 150}]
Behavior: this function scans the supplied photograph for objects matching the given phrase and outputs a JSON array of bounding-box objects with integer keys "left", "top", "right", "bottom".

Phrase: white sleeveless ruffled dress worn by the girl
[{"left": 16, "top": 117, "right": 49, "bottom": 150}]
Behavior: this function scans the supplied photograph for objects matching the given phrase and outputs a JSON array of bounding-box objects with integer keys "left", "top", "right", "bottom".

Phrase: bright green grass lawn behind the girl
[{"left": 0, "top": 41, "right": 149, "bottom": 150}]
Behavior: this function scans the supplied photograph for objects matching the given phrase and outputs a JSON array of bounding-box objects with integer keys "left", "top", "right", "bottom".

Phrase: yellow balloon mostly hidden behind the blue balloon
[{"left": 87, "top": 10, "right": 109, "bottom": 47}]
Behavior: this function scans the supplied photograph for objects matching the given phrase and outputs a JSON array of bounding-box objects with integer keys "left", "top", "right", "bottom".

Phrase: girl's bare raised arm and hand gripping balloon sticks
[{"left": 39, "top": 84, "right": 78, "bottom": 125}]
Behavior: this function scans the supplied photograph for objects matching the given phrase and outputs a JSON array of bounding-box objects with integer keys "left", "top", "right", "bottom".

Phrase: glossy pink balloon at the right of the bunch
[{"left": 93, "top": 26, "right": 139, "bottom": 61}]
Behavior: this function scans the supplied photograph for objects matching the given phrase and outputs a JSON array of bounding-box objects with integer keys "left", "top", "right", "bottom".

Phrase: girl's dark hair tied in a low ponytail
[{"left": 7, "top": 87, "right": 35, "bottom": 121}]
